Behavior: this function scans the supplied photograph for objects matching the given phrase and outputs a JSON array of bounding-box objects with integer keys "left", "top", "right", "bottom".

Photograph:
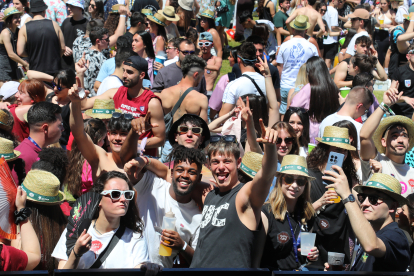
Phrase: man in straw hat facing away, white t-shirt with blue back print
[{"left": 276, "top": 15, "right": 318, "bottom": 114}]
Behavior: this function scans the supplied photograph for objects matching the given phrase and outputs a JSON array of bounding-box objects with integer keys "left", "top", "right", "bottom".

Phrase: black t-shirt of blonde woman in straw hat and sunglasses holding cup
[{"left": 260, "top": 203, "right": 313, "bottom": 271}]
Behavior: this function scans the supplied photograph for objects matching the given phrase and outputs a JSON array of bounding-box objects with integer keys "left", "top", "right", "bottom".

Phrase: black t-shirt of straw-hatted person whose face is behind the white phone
[{"left": 309, "top": 169, "right": 352, "bottom": 267}]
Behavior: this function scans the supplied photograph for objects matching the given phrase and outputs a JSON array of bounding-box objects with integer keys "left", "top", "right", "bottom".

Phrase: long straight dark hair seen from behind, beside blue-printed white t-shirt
[{"left": 306, "top": 57, "right": 339, "bottom": 123}]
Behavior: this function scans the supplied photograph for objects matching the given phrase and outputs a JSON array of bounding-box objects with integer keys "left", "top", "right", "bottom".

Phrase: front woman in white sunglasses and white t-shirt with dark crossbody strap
[{"left": 52, "top": 171, "right": 154, "bottom": 269}]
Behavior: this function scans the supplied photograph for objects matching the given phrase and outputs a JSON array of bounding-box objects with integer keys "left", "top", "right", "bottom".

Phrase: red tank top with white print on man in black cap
[{"left": 113, "top": 86, "right": 161, "bottom": 156}]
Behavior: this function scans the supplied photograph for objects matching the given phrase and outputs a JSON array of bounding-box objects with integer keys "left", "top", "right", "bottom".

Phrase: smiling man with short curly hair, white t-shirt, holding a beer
[{"left": 125, "top": 145, "right": 205, "bottom": 268}]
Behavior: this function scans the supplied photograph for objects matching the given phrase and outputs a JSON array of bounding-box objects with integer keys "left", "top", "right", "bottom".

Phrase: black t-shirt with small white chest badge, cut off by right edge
[{"left": 391, "top": 64, "right": 414, "bottom": 118}]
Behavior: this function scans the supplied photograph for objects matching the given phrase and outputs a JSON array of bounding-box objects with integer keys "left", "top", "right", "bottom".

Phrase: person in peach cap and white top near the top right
[{"left": 344, "top": 8, "right": 369, "bottom": 59}]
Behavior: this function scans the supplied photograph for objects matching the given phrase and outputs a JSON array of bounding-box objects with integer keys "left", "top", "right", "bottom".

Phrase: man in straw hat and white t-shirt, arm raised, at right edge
[{"left": 360, "top": 83, "right": 414, "bottom": 197}]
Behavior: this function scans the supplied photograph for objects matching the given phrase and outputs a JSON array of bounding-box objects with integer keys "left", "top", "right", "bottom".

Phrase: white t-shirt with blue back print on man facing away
[{"left": 276, "top": 37, "right": 319, "bottom": 88}]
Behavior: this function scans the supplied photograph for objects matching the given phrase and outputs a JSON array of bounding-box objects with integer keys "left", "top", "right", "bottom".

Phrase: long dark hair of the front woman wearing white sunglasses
[{"left": 92, "top": 171, "right": 144, "bottom": 236}]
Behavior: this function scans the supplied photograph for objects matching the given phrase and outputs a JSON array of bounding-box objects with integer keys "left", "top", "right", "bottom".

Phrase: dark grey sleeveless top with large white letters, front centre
[{"left": 190, "top": 183, "right": 258, "bottom": 268}]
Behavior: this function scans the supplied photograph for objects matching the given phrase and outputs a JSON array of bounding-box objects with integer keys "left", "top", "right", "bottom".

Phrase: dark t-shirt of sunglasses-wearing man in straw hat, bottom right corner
[{"left": 352, "top": 222, "right": 410, "bottom": 272}]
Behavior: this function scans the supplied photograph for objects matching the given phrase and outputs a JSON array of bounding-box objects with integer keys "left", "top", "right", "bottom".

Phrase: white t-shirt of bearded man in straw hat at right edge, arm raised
[{"left": 361, "top": 153, "right": 414, "bottom": 197}]
